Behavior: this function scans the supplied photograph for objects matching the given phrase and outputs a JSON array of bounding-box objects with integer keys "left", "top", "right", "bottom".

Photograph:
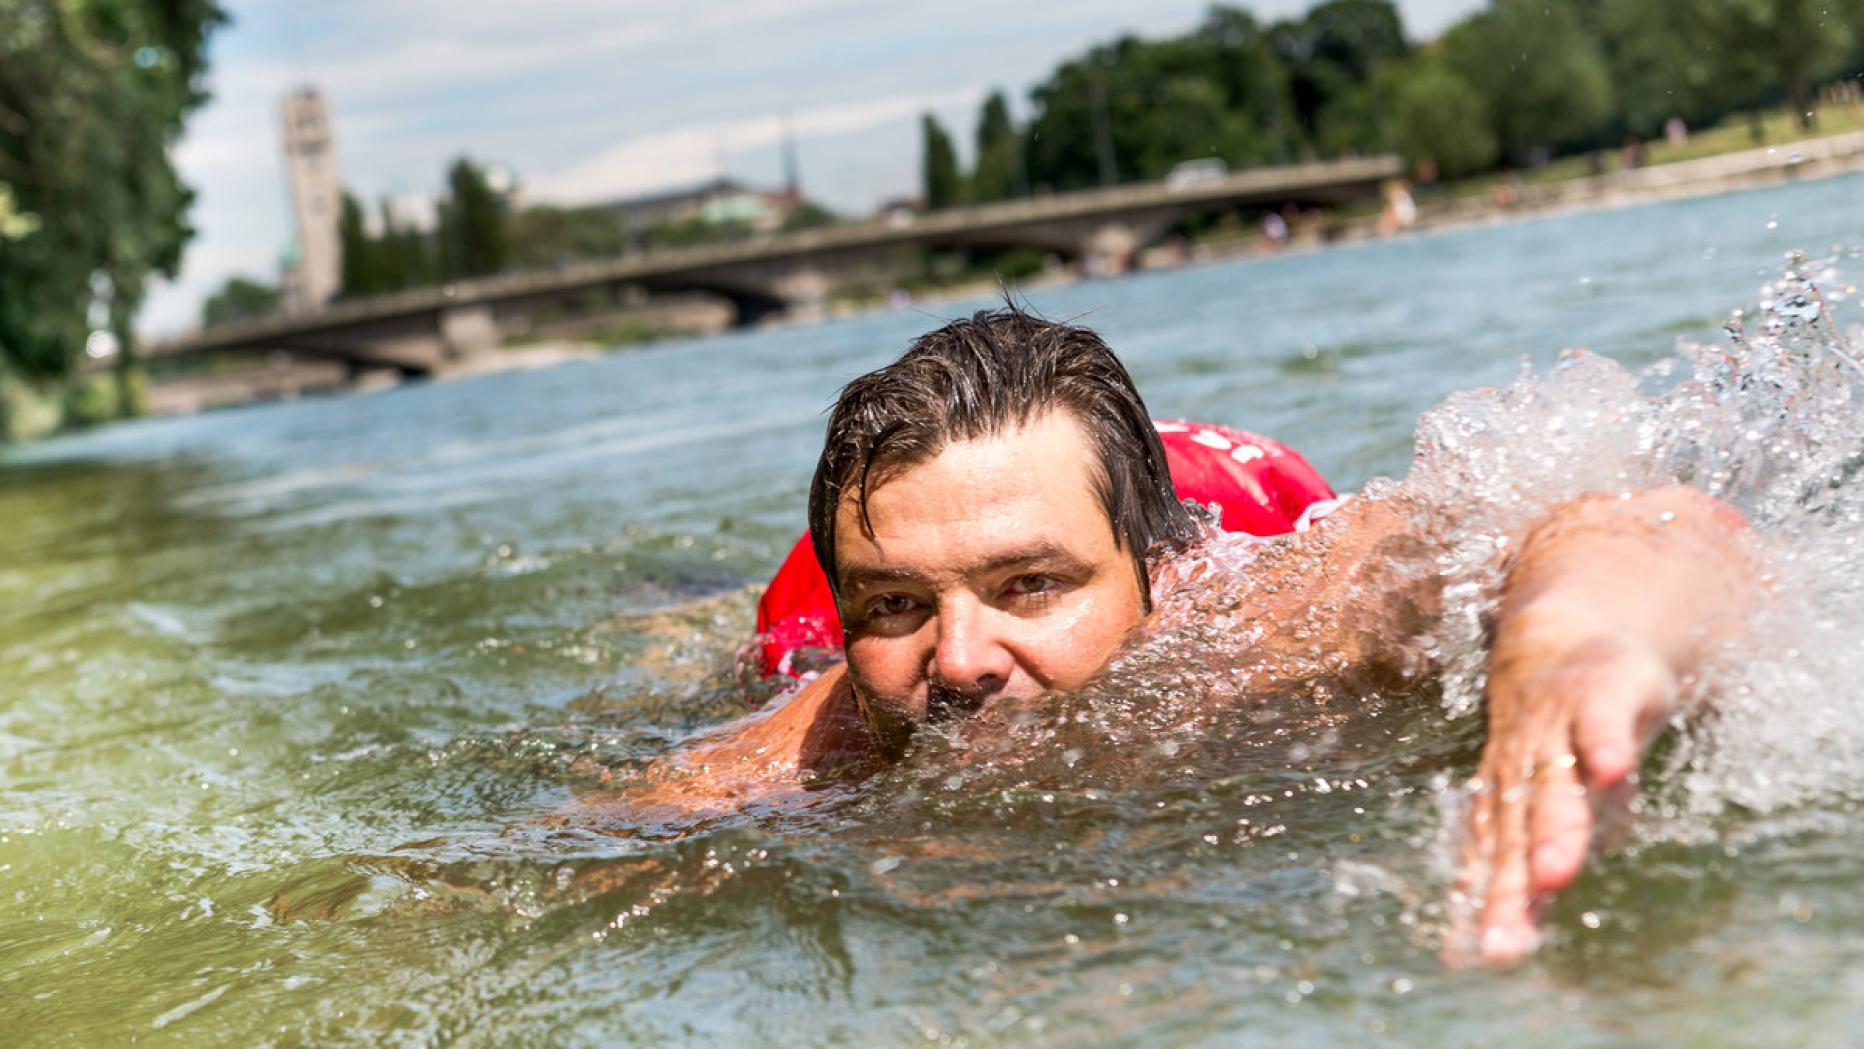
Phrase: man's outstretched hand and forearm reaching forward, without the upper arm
[{"left": 1445, "top": 488, "right": 1760, "bottom": 963}]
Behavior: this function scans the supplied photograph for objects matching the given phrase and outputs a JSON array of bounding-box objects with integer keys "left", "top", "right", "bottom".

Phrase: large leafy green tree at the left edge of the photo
[{"left": 0, "top": 0, "right": 224, "bottom": 398}]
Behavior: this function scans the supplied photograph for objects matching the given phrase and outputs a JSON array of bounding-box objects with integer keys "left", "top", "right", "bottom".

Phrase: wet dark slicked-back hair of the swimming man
[{"left": 809, "top": 306, "right": 1193, "bottom": 611}]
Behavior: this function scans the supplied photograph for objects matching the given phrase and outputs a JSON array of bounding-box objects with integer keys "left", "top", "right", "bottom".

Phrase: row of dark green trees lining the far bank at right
[{"left": 973, "top": 0, "right": 1864, "bottom": 199}]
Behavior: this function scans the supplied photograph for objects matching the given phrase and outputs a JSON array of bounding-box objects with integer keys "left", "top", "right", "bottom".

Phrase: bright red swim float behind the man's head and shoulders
[{"left": 757, "top": 419, "right": 1335, "bottom": 676}]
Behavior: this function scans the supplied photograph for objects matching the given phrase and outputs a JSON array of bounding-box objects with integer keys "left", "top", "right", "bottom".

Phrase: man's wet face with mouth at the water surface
[{"left": 835, "top": 412, "right": 1144, "bottom": 749}]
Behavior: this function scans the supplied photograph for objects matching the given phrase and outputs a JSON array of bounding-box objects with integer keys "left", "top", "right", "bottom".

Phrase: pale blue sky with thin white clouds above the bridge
[{"left": 138, "top": 0, "right": 1482, "bottom": 334}]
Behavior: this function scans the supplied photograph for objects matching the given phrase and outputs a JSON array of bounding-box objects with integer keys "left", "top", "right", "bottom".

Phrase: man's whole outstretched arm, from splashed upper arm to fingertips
[{"left": 1230, "top": 486, "right": 1761, "bottom": 961}]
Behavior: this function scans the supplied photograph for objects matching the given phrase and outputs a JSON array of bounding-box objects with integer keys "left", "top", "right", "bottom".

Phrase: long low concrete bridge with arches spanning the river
[{"left": 144, "top": 157, "right": 1402, "bottom": 376}]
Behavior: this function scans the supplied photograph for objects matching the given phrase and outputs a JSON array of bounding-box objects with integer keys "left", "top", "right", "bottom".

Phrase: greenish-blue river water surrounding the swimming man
[{"left": 0, "top": 177, "right": 1864, "bottom": 1045}]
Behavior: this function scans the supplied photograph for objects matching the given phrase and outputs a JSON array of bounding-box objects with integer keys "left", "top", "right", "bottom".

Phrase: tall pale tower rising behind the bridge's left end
[{"left": 280, "top": 88, "right": 343, "bottom": 313}]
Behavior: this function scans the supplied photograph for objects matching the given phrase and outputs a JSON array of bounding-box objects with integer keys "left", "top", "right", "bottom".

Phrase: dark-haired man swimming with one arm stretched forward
[{"left": 577, "top": 309, "right": 1758, "bottom": 961}]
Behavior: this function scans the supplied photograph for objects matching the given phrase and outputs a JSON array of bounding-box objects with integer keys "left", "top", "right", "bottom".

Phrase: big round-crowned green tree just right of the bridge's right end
[{"left": 1443, "top": 0, "right": 1612, "bottom": 164}]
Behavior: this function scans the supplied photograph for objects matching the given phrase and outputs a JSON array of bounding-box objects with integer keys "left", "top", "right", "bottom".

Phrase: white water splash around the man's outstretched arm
[{"left": 1113, "top": 255, "right": 1864, "bottom": 837}]
